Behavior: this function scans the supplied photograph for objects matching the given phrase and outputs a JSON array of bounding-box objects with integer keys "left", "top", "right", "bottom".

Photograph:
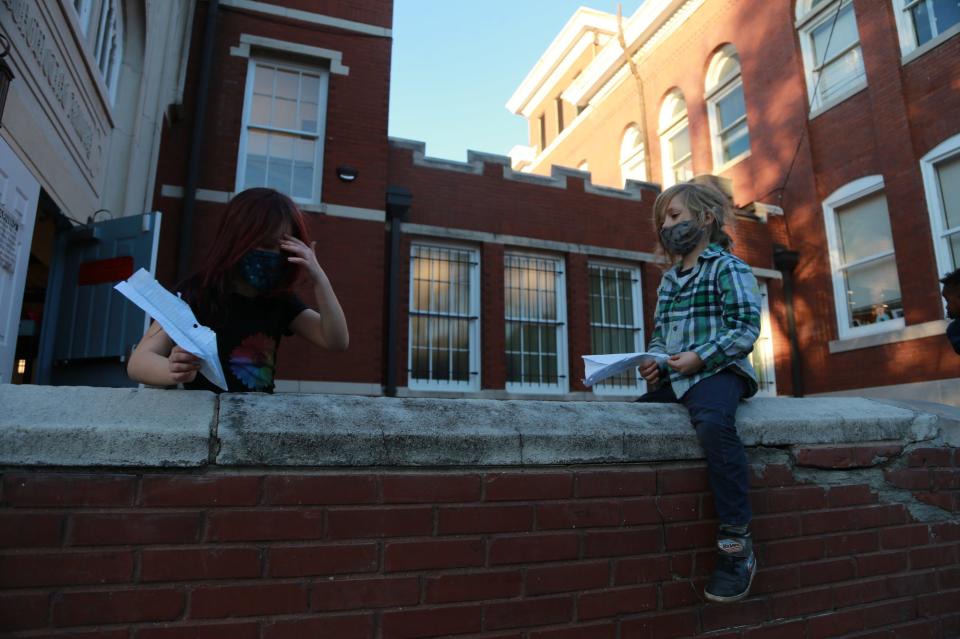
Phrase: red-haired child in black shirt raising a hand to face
[{"left": 127, "top": 188, "right": 349, "bottom": 393}]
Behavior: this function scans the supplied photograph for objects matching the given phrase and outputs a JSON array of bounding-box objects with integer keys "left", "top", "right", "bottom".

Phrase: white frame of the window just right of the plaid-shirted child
[{"left": 823, "top": 175, "right": 905, "bottom": 339}]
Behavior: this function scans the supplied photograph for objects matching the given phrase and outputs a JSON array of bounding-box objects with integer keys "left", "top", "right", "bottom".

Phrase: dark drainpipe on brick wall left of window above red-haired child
[{"left": 177, "top": 0, "right": 220, "bottom": 281}]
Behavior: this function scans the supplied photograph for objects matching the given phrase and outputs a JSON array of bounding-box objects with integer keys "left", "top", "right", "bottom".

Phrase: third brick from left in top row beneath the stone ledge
[{"left": 263, "top": 474, "right": 379, "bottom": 506}]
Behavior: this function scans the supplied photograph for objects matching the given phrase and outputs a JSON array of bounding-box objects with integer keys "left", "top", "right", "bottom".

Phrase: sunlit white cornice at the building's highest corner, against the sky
[{"left": 507, "top": 8, "right": 620, "bottom": 117}]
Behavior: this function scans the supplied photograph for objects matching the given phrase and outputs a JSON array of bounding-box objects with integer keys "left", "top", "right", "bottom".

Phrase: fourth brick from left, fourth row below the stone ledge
[{"left": 310, "top": 577, "right": 420, "bottom": 612}]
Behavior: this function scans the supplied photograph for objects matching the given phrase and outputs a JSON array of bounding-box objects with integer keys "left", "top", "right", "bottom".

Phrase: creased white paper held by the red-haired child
[{"left": 114, "top": 269, "right": 227, "bottom": 390}]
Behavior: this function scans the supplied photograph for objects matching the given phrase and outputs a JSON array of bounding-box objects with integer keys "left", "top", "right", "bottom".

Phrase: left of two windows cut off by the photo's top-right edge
[{"left": 797, "top": 0, "right": 867, "bottom": 114}]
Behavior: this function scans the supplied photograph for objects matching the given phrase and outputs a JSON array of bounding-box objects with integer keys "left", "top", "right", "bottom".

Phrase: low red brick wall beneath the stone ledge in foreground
[{"left": 0, "top": 442, "right": 960, "bottom": 639}]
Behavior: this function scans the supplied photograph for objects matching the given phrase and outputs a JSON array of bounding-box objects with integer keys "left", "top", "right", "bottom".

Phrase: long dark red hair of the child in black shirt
[{"left": 180, "top": 187, "right": 310, "bottom": 323}]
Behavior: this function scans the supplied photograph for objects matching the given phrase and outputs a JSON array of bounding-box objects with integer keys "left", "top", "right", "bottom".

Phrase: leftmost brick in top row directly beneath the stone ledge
[{"left": 3, "top": 473, "right": 137, "bottom": 508}]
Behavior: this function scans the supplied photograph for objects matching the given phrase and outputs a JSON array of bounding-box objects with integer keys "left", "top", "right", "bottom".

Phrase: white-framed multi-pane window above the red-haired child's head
[{"left": 236, "top": 58, "right": 329, "bottom": 203}]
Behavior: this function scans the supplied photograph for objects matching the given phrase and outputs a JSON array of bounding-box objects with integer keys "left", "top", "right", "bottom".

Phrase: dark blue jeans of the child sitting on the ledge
[{"left": 637, "top": 369, "right": 752, "bottom": 526}]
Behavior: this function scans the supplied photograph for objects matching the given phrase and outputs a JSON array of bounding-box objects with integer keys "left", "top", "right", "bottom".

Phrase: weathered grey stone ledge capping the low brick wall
[{"left": 0, "top": 385, "right": 960, "bottom": 467}]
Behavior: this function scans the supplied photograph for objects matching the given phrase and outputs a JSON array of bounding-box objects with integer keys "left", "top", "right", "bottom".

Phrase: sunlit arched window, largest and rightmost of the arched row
[{"left": 706, "top": 44, "right": 750, "bottom": 171}]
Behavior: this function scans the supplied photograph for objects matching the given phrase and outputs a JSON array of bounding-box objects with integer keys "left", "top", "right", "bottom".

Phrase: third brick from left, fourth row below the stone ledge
[{"left": 190, "top": 582, "right": 307, "bottom": 619}]
